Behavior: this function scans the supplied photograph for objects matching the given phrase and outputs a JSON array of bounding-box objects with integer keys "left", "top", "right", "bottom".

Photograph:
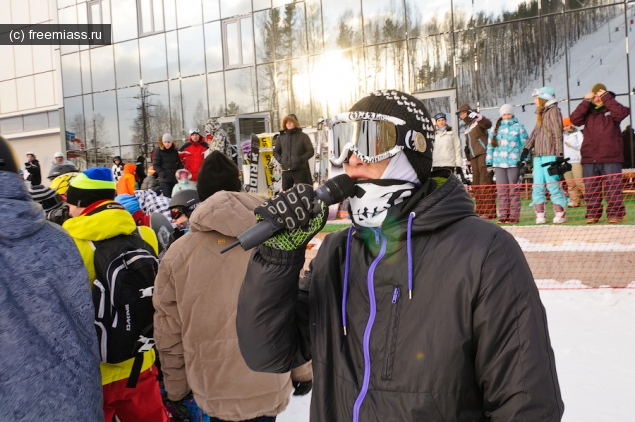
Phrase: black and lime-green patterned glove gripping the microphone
[{"left": 254, "top": 184, "right": 328, "bottom": 251}]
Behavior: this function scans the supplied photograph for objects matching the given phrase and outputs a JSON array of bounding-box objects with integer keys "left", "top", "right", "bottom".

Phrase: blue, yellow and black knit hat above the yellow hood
[{"left": 66, "top": 167, "right": 117, "bottom": 208}]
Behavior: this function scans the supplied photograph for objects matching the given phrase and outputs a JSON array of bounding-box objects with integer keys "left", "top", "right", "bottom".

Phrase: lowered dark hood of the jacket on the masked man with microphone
[{"left": 357, "top": 172, "right": 476, "bottom": 243}]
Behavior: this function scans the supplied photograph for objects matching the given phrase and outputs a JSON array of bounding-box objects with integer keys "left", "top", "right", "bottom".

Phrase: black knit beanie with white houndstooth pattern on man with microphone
[{"left": 350, "top": 89, "right": 434, "bottom": 183}]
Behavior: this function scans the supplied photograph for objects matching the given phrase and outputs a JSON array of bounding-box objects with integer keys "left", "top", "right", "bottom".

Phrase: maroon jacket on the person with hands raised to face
[{"left": 571, "top": 92, "right": 631, "bottom": 164}]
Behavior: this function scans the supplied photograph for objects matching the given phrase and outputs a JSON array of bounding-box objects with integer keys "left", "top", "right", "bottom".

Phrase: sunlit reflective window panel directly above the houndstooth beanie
[{"left": 365, "top": 41, "right": 408, "bottom": 91}]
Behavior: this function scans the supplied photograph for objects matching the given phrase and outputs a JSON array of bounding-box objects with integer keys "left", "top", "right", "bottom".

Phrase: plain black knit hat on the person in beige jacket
[{"left": 196, "top": 151, "right": 241, "bottom": 202}]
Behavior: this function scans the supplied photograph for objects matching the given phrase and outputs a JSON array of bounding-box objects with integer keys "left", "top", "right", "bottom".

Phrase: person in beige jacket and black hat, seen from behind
[{"left": 153, "top": 151, "right": 312, "bottom": 421}]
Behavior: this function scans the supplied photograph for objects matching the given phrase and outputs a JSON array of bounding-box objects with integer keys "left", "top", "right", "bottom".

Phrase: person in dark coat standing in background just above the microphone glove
[{"left": 273, "top": 114, "right": 314, "bottom": 190}]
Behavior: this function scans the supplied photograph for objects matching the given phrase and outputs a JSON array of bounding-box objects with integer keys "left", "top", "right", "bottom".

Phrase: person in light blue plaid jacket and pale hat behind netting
[{"left": 485, "top": 104, "right": 529, "bottom": 224}]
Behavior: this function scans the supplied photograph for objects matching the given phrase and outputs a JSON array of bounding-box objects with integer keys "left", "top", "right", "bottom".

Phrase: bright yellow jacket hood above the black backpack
[{"left": 62, "top": 201, "right": 137, "bottom": 241}]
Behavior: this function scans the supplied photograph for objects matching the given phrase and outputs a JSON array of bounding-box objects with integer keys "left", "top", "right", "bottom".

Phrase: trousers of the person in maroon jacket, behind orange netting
[{"left": 582, "top": 163, "right": 626, "bottom": 219}]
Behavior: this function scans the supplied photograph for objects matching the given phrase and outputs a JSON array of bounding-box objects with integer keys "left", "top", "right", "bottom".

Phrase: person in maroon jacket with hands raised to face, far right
[{"left": 571, "top": 84, "right": 631, "bottom": 224}]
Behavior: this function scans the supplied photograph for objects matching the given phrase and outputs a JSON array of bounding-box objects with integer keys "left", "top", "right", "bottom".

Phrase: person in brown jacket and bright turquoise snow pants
[{"left": 521, "top": 86, "right": 567, "bottom": 224}]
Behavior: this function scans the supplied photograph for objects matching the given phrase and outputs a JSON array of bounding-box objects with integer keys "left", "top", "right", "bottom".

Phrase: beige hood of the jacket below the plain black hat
[{"left": 190, "top": 191, "right": 263, "bottom": 237}]
